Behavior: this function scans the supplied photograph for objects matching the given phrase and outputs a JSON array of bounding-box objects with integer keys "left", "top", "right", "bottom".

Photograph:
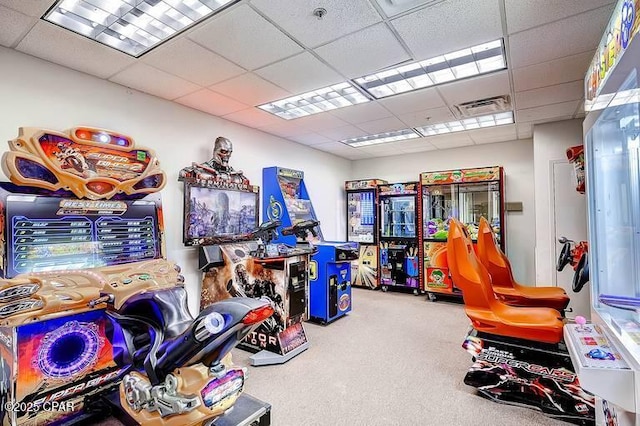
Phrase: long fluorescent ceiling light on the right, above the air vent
[{"left": 355, "top": 39, "right": 507, "bottom": 99}]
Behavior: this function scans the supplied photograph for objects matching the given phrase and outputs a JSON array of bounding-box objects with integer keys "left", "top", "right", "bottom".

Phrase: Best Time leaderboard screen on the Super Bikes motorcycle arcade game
[{"left": 3, "top": 194, "right": 161, "bottom": 278}]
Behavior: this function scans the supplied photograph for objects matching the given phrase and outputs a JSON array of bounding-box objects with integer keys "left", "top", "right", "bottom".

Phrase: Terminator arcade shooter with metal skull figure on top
[{"left": 179, "top": 137, "right": 311, "bottom": 365}]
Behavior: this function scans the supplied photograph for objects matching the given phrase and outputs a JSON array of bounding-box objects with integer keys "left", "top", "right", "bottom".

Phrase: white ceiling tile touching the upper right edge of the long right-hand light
[{"left": 391, "top": 0, "right": 502, "bottom": 60}]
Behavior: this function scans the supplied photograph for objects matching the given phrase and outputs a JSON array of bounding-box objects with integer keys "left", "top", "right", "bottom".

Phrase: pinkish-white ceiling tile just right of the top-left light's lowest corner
[{"left": 142, "top": 38, "right": 246, "bottom": 86}]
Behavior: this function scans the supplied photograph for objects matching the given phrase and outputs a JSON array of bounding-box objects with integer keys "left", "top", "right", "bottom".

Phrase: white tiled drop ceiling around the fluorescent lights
[{"left": 0, "top": 0, "right": 614, "bottom": 160}]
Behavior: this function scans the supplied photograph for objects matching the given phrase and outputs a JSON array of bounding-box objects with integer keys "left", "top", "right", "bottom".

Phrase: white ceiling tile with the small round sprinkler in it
[{"left": 251, "top": 0, "right": 382, "bottom": 47}]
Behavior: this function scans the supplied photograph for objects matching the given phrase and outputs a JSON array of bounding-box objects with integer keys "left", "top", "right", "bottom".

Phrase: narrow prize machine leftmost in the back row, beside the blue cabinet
[{"left": 345, "top": 179, "right": 387, "bottom": 290}]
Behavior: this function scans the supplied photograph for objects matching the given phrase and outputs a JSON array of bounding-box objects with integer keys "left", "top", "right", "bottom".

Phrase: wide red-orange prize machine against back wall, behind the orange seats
[{"left": 420, "top": 167, "right": 505, "bottom": 301}]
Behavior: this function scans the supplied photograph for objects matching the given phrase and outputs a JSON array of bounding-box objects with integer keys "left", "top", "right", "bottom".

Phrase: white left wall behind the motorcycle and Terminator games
[{"left": 0, "top": 48, "right": 351, "bottom": 310}]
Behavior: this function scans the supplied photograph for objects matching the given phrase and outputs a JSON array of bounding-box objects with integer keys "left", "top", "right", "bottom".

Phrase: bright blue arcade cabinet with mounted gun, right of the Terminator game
[{"left": 262, "top": 167, "right": 358, "bottom": 324}]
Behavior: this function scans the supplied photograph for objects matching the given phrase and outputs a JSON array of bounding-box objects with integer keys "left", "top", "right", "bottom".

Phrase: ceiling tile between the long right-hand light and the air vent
[{"left": 438, "top": 71, "right": 511, "bottom": 105}]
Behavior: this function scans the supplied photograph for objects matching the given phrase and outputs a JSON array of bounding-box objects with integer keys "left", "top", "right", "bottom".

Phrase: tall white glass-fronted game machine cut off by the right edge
[{"left": 564, "top": 0, "right": 640, "bottom": 425}]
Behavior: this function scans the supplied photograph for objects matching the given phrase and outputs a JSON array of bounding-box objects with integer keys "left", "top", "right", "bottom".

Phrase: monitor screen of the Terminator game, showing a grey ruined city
[{"left": 184, "top": 184, "right": 259, "bottom": 246}]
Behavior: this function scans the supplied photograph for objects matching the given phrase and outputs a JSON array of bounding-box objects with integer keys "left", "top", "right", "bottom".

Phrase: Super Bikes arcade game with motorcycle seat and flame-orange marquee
[{"left": 0, "top": 127, "right": 272, "bottom": 425}]
